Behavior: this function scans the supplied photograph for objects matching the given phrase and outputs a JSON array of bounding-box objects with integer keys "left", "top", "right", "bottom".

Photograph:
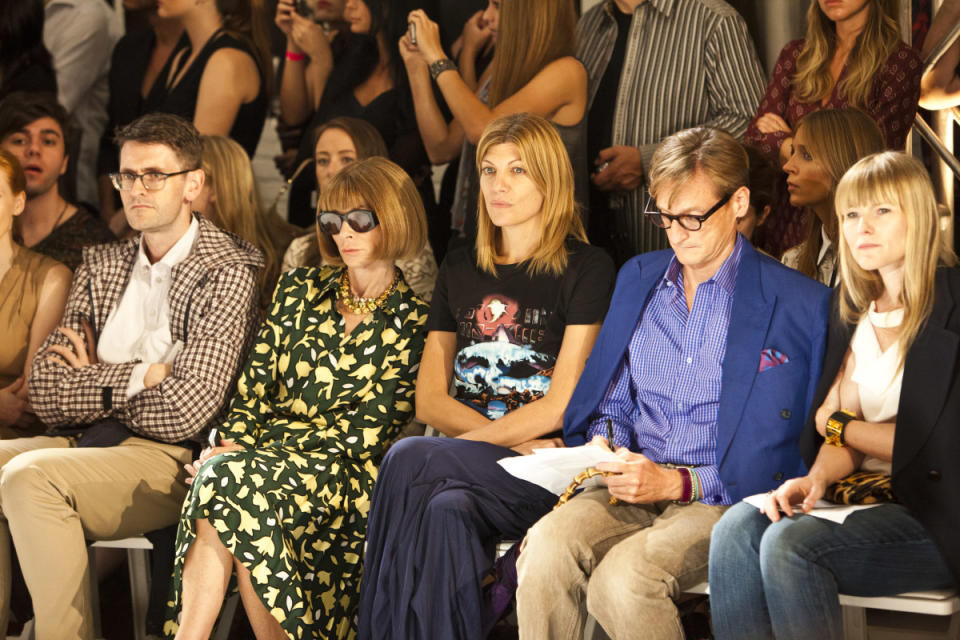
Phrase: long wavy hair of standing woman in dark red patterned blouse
[{"left": 793, "top": 0, "right": 901, "bottom": 108}]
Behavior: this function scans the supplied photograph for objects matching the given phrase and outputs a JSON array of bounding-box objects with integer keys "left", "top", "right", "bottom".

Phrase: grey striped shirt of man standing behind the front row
[{"left": 577, "top": 0, "right": 764, "bottom": 253}]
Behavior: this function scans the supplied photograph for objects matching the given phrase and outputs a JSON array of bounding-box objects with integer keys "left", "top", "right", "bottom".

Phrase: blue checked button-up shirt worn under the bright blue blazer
[{"left": 587, "top": 234, "right": 745, "bottom": 504}]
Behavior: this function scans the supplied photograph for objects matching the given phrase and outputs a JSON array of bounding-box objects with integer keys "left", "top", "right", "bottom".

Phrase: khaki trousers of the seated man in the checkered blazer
[{"left": 0, "top": 436, "right": 191, "bottom": 640}]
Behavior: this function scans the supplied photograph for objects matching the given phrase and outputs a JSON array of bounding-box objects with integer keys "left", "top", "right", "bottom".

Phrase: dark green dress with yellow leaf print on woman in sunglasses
[{"left": 164, "top": 267, "right": 427, "bottom": 639}]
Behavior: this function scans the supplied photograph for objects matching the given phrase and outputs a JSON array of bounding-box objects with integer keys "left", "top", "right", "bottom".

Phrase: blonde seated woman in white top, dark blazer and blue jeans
[{"left": 709, "top": 152, "right": 960, "bottom": 640}]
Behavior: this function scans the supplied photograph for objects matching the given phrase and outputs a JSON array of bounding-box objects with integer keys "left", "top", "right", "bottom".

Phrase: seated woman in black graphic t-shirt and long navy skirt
[{"left": 359, "top": 114, "right": 614, "bottom": 638}]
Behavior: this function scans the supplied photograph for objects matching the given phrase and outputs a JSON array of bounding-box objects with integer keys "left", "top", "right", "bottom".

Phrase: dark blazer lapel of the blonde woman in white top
[{"left": 892, "top": 274, "right": 960, "bottom": 475}]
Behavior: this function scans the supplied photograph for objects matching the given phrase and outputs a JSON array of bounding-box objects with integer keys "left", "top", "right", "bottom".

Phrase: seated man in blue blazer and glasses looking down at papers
[{"left": 517, "top": 127, "right": 830, "bottom": 640}]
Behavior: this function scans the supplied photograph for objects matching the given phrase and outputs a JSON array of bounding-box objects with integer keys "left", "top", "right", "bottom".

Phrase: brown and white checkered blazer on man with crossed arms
[{"left": 29, "top": 218, "right": 263, "bottom": 442}]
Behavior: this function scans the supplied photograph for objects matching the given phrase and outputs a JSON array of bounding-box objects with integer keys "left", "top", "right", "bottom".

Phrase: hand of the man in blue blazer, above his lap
[{"left": 597, "top": 447, "right": 683, "bottom": 504}]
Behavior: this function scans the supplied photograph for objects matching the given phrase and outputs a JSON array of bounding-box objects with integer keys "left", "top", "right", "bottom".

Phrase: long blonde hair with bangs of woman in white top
[{"left": 835, "top": 151, "right": 957, "bottom": 367}]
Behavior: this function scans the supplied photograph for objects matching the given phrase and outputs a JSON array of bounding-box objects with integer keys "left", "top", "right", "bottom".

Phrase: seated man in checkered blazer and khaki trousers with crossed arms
[{"left": 0, "top": 114, "right": 263, "bottom": 640}]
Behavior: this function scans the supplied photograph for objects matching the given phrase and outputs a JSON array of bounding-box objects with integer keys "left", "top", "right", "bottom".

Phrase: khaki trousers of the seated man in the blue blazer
[{"left": 517, "top": 488, "right": 727, "bottom": 640}]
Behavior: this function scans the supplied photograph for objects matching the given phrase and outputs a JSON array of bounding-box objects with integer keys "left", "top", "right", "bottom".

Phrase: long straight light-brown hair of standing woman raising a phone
[{"left": 489, "top": 0, "right": 577, "bottom": 107}]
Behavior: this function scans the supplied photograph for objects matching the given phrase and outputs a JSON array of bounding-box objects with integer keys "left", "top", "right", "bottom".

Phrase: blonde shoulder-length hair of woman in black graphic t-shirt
[{"left": 477, "top": 113, "right": 587, "bottom": 276}]
